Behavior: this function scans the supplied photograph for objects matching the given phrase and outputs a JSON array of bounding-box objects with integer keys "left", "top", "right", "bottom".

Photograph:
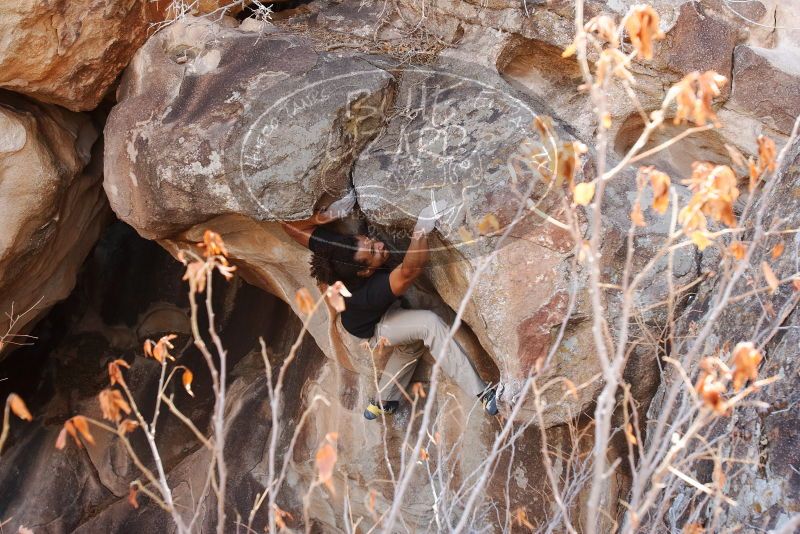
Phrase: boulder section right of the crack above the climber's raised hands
[{"left": 353, "top": 57, "right": 599, "bottom": 426}]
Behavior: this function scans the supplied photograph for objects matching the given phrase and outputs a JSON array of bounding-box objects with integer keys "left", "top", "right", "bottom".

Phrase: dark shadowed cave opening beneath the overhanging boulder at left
[{"left": 0, "top": 221, "right": 299, "bottom": 449}]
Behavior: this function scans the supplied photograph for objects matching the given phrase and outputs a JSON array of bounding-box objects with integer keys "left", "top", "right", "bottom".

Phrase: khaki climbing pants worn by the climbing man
[{"left": 369, "top": 304, "right": 487, "bottom": 401}]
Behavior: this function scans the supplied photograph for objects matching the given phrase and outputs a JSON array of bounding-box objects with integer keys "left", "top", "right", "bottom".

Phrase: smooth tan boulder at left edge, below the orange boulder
[{"left": 0, "top": 92, "right": 109, "bottom": 358}]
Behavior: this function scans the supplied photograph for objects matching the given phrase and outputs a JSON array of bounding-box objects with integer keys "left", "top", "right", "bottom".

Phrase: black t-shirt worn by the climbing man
[{"left": 308, "top": 227, "right": 398, "bottom": 339}]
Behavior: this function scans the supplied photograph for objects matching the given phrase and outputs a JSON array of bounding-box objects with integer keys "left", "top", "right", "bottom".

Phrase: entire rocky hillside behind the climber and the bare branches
[{"left": 0, "top": 0, "right": 800, "bottom": 534}]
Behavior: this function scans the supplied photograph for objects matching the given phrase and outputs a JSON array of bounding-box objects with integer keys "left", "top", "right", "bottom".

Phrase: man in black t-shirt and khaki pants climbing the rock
[{"left": 281, "top": 191, "right": 497, "bottom": 420}]
